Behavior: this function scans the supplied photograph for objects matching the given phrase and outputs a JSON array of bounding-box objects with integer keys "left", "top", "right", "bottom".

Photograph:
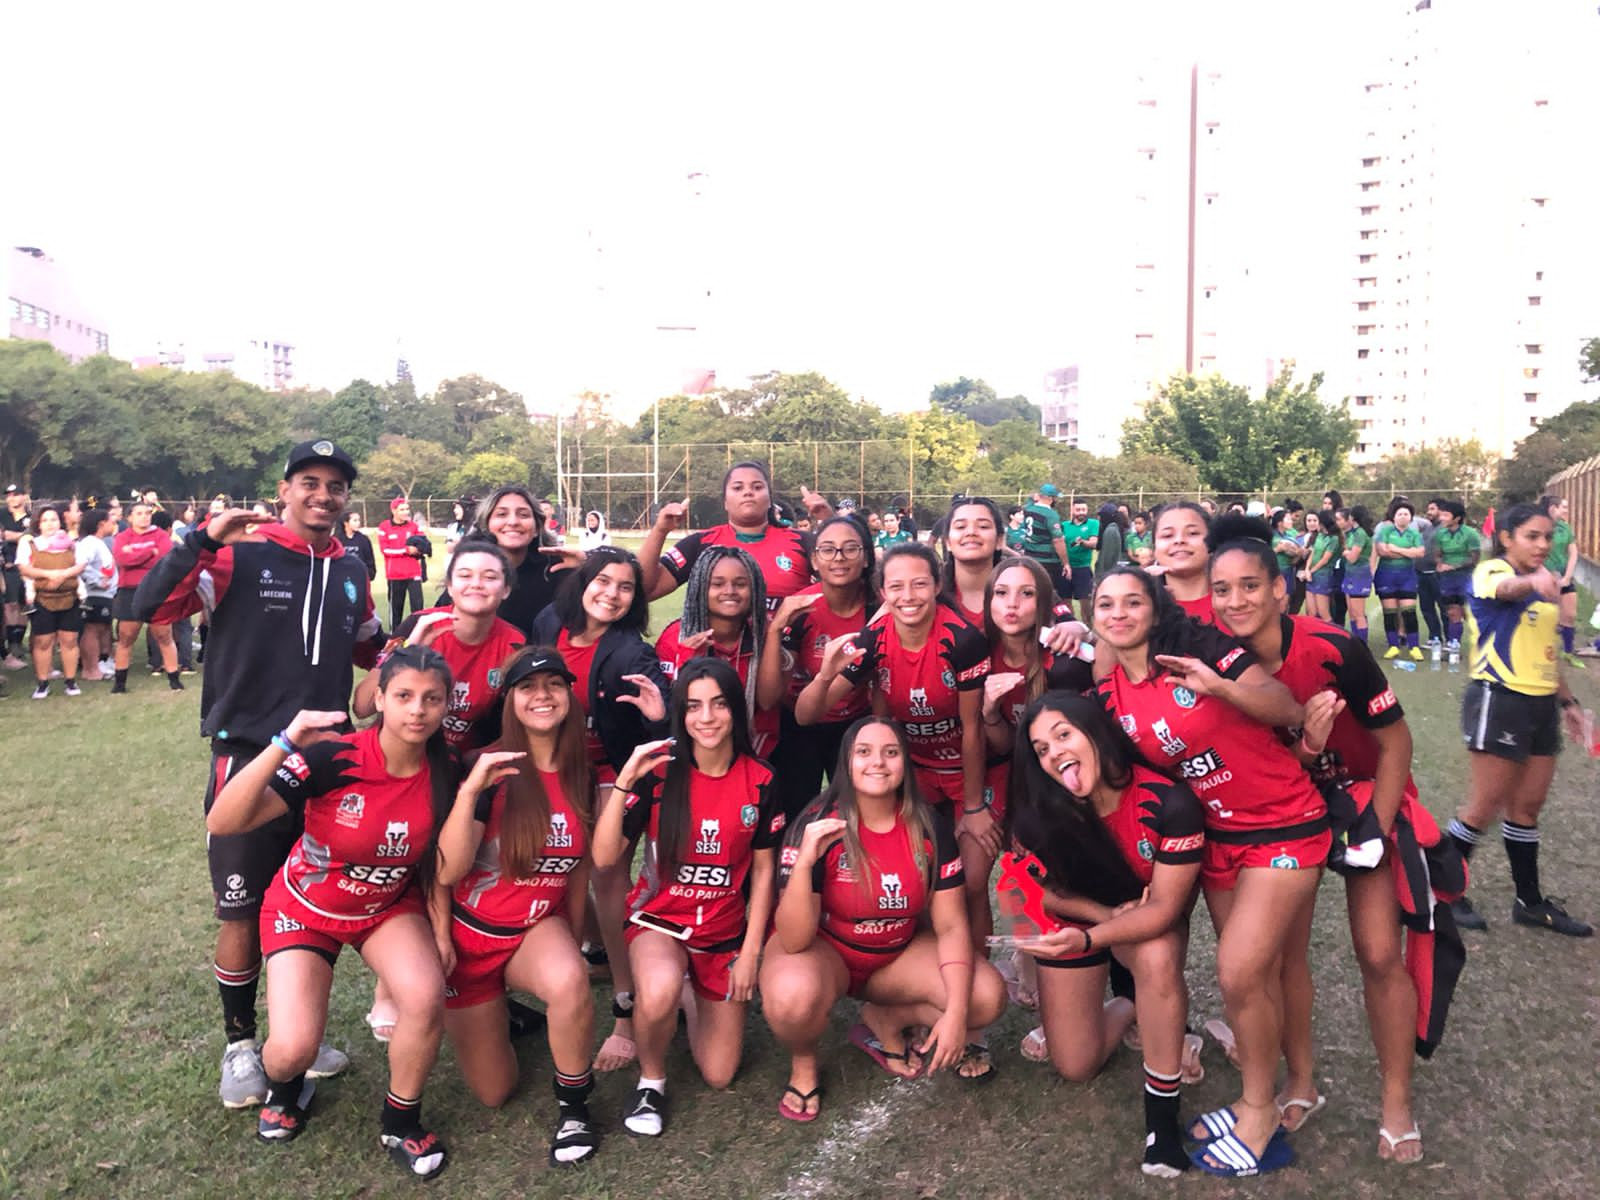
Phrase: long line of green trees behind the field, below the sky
[{"left": 0, "top": 339, "right": 1600, "bottom": 520}]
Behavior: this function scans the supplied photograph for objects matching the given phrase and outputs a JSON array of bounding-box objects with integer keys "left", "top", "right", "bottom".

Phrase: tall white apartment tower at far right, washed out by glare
[{"left": 1350, "top": 0, "right": 1600, "bottom": 462}]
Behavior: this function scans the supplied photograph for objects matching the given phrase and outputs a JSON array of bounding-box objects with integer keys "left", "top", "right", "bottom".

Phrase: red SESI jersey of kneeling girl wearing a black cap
[{"left": 453, "top": 771, "right": 589, "bottom": 934}]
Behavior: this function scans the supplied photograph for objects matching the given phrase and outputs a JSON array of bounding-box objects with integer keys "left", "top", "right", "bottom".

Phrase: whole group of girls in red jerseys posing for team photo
[{"left": 196, "top": 464, "right": 1465, "bottom": 1178}]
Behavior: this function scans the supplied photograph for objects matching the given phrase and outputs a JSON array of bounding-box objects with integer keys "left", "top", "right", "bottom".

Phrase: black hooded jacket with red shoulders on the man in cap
[{"left": 133, "top": 523, "right": 382, "bottom": 746}]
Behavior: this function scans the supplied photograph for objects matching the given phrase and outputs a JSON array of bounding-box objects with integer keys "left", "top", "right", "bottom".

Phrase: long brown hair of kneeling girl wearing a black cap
[{"left": 488, "top": 646, "right": 595, "bottom": 878}]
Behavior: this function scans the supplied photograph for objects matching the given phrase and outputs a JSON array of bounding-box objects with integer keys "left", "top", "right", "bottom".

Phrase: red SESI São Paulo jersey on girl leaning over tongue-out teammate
[{"left": 1099, "top": 626, "right": 1328, "bottom": 832}]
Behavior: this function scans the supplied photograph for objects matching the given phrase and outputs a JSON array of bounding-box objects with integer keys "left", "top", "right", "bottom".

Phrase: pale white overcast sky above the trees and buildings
[{"left": 0, "top": 0, "right": 1402, "bottom": 419}]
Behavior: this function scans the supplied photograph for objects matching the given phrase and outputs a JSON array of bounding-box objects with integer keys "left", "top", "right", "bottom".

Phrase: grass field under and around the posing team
[{"left": 0, "top": 579, "right": 1600, "bottom": 1200}]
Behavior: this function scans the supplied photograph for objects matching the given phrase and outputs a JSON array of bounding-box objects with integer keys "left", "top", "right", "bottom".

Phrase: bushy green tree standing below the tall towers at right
[{"left": 1123, "top": 365, "right": 1355, "bottom": 493}]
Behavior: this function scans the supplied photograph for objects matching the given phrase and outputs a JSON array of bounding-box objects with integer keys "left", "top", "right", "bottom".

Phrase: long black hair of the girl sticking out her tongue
[{"left": 1005, "top": 691, "right": 1142, "bottom": 906}]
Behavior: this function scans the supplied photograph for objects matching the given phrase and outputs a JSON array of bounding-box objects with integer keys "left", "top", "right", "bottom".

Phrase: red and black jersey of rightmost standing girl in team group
[{"left": 1277, "top": 616, "right": 1405, "bottom": 782}]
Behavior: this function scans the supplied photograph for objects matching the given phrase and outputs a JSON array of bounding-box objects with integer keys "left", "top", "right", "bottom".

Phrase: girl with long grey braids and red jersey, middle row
[{"left": 656, "top": 546, "right": 778, "bottom": 758}]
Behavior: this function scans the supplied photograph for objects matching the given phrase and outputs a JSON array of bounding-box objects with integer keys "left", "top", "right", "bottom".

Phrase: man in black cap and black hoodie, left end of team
[{"left": 133, "top": 440, "right": 382, "bottom": 1109}]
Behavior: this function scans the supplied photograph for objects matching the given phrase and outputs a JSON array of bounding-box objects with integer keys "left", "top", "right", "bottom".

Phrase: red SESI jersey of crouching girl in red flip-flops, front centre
[{"left": 778, "top": 805, "right": 966, "bottom": 952}]
